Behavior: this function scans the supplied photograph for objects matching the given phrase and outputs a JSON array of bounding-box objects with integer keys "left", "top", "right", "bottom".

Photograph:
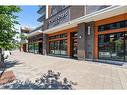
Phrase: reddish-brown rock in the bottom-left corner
[{"left": 0, "top": 71, "right": 16, "bottom": 85}]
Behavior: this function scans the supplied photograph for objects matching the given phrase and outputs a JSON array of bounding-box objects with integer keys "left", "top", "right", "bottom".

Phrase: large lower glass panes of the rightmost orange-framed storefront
[{"left": 99, "top": 33, "right": 124, "bottom": 61}]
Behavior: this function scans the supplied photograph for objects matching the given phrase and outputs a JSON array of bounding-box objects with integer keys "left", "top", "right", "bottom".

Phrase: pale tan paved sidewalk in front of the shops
[{"left": 1, "top": 51, "right": 127, "bottom": 89}]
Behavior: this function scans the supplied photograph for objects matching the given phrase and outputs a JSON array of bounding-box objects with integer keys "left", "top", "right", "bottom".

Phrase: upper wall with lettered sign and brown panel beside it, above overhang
[{"left": 44, "top": 6, "right": 84, "bottom": 30}]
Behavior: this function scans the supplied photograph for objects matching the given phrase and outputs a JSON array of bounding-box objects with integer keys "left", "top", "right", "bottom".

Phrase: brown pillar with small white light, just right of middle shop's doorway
[{"left": 77, "top": 23, "right": 85, "bottom": 60}]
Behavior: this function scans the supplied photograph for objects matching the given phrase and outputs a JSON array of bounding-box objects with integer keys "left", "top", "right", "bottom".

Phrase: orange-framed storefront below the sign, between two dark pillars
[{"left": 48, "top": 27, "right": 77, "bottom": 57}]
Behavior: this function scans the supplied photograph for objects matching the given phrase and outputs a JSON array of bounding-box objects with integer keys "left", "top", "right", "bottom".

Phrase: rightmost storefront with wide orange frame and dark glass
[{"left": 94, "top": 14, "right": 127, "bottom": 61}]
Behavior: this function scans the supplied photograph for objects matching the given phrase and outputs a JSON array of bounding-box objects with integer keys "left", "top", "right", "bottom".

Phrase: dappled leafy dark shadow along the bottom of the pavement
[{"left": 1, "top": 70, "right": 77, "bottom": 90}]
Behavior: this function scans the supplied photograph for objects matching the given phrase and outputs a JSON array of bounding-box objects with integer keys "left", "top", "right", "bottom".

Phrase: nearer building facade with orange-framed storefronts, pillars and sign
[{"left": 23, "top": 5, "right": 127, "bottom": 62}]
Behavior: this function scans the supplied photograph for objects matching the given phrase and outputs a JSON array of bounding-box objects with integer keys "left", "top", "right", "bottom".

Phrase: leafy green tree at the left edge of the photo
[{"left": 0, "top": 6, "right": 21, "bottom": 50}]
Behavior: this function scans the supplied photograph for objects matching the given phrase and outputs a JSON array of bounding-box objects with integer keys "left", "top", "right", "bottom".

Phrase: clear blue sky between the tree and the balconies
[{"left": 17, "top": 5, "right": 40, "bottom": 28}]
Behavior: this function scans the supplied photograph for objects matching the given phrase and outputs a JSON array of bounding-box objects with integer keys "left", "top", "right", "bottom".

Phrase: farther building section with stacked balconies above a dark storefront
[{"left": 27, "top": 6, "right": 47, "bottom": 54}]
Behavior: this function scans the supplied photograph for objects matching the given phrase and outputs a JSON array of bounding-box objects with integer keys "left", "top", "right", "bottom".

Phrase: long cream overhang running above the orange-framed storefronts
[{"left": 42, "top": 6, "right": 127, "bottom": 34}]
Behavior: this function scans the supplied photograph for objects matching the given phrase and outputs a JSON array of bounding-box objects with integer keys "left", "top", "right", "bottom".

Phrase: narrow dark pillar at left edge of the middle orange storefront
[{"left": 43, "top": 34, "right": 49, "bottom": 55}]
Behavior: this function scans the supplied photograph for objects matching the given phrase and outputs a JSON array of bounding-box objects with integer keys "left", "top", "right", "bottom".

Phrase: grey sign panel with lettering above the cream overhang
[{"left": 48, "top": 10, "right": 69, "bottom": 28}]
